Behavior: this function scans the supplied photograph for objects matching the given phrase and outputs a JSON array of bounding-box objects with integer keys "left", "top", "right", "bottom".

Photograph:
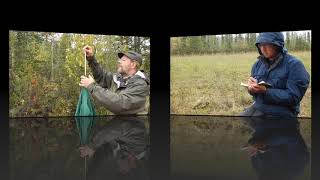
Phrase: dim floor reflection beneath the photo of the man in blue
[{"left": 170, "top": 116, "right": 311, "bottom": 180}]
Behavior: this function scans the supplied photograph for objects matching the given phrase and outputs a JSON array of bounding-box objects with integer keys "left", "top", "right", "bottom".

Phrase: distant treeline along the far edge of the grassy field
[{"left": 171, "top": 31, "right": 311, "bottom": 55}]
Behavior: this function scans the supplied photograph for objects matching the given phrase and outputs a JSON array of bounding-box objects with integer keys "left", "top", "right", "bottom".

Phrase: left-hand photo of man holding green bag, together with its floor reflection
[{"left": 8, "top": 30, "right": 151, "bottom": 179}]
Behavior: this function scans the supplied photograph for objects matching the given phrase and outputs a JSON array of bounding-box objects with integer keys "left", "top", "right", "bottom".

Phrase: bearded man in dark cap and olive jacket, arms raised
[{"left": 79, "top": 46, "right": 149, "bottom": 114}]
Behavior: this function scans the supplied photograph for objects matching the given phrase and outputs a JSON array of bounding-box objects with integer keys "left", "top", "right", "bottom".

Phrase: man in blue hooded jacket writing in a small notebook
[{"left": 240, "top": 32, "right": 310, "bottom": 117}]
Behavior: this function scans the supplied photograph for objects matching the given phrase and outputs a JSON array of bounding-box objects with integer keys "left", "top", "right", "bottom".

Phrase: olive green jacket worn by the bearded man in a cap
[{"left": 87, "top": 58, "right": 149, "bottom": 114}]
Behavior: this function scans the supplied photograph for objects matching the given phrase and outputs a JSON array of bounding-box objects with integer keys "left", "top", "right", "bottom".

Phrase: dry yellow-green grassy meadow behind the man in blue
[{"left": 170, "top": 51, "right": 311, "bottom": 117}]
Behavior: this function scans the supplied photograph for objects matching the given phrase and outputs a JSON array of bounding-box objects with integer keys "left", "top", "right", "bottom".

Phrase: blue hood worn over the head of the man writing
[{"left": 255, "top": 32, "right": 288, "bottom": 55}]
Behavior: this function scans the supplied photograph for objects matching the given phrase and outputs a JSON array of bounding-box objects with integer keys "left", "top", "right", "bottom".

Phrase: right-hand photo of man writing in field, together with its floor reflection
[{"left": 170, "top": 30, "right": 312, "bottom": 180}]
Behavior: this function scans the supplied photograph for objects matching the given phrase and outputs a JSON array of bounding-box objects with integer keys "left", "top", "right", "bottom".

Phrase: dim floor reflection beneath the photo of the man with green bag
[{"left": 9, "top": 116, "right": 150, "bottom": 180}]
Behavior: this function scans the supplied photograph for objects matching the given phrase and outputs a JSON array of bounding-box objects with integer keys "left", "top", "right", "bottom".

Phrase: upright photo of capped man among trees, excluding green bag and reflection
[{"left": 9, "top": 31, "right": 150, "bottom": 117}]
